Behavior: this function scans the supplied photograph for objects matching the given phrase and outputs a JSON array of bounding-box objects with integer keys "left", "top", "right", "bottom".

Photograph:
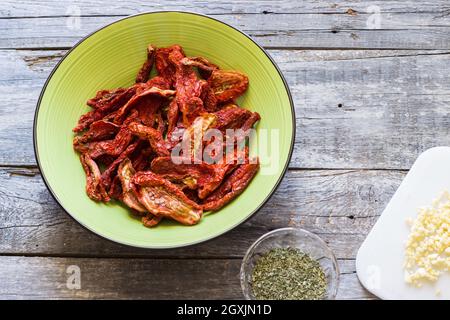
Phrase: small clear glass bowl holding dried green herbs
[{"left": 240, "top": 228, "right": 339, "bottom": 300}]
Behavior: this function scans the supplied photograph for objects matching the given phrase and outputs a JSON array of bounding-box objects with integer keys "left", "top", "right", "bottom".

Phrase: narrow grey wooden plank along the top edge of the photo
[{"left": 0, "top": 0, "right": 448, "bottom": 17}]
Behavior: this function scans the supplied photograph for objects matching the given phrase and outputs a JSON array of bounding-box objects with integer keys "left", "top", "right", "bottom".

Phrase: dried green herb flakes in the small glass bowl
[{"left": 252, "top": 248, "right": 327, "bottom": 300}]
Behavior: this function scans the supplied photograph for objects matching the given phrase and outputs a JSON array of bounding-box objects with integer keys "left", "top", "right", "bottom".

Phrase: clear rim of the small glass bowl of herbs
[{"left": 239, "top": 227, "right": 341, "bottom": 300}]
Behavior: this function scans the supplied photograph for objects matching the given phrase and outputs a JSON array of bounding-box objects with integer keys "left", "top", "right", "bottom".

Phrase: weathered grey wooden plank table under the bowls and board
[{"left": 0, "top": 0, "right": 450, "bottom": 299}]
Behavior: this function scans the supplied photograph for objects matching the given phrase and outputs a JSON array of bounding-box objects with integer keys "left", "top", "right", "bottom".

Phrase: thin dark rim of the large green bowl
[{"left": 33, "top": 10, "right": 296, "bottom": 249}]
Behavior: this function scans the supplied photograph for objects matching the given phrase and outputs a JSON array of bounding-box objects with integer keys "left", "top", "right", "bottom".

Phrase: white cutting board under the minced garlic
[{"left": 356, "top": 147, "right": 450, "bottom": 300}]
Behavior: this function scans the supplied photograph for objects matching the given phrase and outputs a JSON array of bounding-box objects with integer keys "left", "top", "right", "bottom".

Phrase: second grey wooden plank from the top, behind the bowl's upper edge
[{"left": 0, "top": 12, "right": 450, "bottom": 49}]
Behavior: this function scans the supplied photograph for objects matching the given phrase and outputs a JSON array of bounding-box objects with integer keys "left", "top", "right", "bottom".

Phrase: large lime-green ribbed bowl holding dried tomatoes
[{"left": 34, "top": 12, "right": 295, "bottom": 248}]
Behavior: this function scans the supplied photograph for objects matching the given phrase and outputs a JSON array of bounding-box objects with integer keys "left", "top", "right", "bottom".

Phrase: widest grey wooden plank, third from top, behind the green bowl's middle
[{"left": 0, "top": 50, "right": 450, "bottom": 169}]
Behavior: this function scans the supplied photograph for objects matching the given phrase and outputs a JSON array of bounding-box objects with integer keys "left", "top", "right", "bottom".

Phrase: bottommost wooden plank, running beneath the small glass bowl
[{"left": 0, "top": 256, "right": 374, "bottom": 299}]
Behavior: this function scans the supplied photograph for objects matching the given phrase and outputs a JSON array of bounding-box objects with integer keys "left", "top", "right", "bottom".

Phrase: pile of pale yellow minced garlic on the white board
[{"left": 405, "top": 191, "right": 450, "bottom": 287}]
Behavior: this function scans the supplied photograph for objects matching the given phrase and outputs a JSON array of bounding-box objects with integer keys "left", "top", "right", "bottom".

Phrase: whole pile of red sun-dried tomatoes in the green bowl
[{"left": 73, "top": 45, "right": 260, "bottom": 227}]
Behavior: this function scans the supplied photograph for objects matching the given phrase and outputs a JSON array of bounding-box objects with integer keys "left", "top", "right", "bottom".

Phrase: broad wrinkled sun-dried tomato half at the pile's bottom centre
[{"left": 133, "top": 171, "right": 203, "bottom": 225}]
